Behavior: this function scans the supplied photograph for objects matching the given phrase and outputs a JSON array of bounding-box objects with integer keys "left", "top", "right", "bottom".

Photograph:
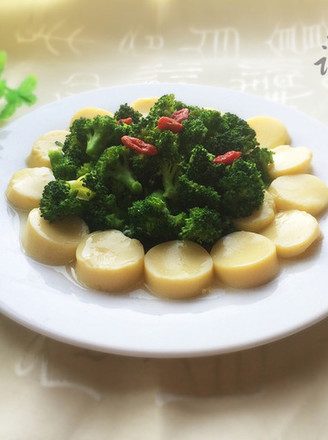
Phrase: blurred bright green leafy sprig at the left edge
[{"left": 0, "top": 51, "right": 37, "bottom": 121}]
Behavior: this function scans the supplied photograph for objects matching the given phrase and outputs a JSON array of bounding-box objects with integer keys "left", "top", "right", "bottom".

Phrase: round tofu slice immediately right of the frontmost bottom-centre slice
[{"left": 211, "top": 231, "right": 279, "bottom": 288}]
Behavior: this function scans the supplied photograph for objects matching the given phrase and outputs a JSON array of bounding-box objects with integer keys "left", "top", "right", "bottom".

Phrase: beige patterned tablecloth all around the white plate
[{"left": 0, "top": 0, "right": 328, "bottom": 440}]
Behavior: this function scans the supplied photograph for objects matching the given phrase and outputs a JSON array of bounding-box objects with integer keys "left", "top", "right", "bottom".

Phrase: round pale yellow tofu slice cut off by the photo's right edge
[{"left": 268, "top": 174, "right": 328, "bottom": 216}]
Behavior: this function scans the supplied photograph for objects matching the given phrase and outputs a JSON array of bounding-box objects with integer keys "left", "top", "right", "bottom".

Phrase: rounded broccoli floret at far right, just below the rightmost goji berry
[{"left": 219, "top": 158, "right": 265, "bottom": 218}]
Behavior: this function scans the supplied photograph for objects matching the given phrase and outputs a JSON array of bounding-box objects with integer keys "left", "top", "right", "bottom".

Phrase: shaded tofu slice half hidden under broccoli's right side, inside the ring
[{"left": 234, "top": 191, "right": 276, "bottom": 232}]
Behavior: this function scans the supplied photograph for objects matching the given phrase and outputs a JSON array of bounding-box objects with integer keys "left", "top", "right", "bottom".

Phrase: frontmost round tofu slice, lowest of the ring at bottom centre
[{"left": 145, "top": 240, "right": 213, "bottom": 299}]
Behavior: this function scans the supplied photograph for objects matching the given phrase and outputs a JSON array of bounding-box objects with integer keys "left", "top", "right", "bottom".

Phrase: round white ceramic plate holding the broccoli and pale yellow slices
[{"left": 0, "top": 84, "right": 328, "bottom": 357}]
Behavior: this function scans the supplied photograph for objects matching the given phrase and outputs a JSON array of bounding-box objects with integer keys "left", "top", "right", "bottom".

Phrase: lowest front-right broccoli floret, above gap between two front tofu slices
[{"left": 179, "top": 207, "right": 234, "bottom": 249}]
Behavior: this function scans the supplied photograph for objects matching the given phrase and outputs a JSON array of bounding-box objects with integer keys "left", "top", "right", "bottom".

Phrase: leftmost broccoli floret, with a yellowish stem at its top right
[{"left": 40, "top": 179, "right": 95, "bottom": 222}]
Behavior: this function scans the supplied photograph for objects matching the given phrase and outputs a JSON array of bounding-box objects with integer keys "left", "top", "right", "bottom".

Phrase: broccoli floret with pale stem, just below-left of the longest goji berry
[{"left": 94, "top": 145, "right": 142, "bottom": 195}]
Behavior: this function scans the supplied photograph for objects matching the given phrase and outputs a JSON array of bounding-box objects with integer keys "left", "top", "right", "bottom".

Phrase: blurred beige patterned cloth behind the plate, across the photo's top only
[{"left": 0, "top": 0, "right": 328, "bottom": 122}]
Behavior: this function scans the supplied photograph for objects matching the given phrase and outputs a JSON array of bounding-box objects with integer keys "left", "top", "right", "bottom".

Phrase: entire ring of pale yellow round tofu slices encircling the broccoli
[{"left": 6, "top": 105, "right": 328, "bottom": 299}]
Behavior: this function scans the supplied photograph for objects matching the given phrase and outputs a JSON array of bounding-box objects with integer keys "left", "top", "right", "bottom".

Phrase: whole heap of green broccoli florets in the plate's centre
[{"left": 40, "top": 94, "right": 272, "bottom": 249}]
